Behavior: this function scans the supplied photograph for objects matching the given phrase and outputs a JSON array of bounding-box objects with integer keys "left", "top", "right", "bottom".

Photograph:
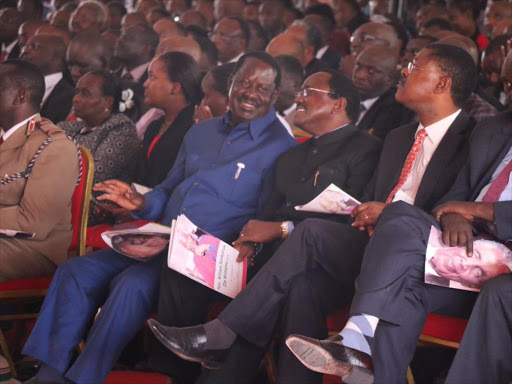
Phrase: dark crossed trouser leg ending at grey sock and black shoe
[{"left": 219, "top": 219, "right": 366, "bottom": 347}]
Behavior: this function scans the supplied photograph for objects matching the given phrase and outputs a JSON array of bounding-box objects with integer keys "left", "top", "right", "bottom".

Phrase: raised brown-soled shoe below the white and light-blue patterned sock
[{"left": 286, "top": 338, "right": 373, "bottom": 384}]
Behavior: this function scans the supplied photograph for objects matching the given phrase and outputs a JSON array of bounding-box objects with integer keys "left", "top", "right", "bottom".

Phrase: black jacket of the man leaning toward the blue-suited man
[{"left": 261, "top": 124, "right": 381, "bottom": 222}]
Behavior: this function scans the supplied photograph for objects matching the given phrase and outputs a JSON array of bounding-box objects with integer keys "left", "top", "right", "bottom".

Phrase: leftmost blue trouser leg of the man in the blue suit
[{"left": 23, "top": 250, "right": 135, "bottom": 372}]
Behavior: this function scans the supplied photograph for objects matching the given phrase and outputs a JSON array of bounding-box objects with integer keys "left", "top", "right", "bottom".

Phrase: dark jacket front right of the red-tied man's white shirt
[{"left": 414, "top": 112, "right": 469, "bottom": 207}]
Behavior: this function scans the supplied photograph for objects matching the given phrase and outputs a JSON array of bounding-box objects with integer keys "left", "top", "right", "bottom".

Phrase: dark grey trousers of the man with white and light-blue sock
[{"left": 351, "top": 203, "right": 474, "bottom": 383}]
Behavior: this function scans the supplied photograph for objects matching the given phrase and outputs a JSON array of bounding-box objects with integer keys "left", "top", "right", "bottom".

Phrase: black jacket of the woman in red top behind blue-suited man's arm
[{"left": 135, "top": 105, "right": 194, "bottom": 188}]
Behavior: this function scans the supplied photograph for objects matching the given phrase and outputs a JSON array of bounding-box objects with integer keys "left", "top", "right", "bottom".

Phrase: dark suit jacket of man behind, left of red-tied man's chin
[{"left": 357, "top": 87, "right": 415, "bottom": 140}]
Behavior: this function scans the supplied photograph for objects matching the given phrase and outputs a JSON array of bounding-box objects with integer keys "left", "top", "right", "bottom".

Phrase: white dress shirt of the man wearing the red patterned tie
[{"left": 393, "top": 109, "right": 461, "bottom": 205}]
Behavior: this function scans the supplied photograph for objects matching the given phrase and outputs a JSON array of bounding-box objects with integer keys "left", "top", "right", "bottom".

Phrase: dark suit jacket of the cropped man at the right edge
[{"left": 441, "top": 111, "right": 512, "bottom": 241}]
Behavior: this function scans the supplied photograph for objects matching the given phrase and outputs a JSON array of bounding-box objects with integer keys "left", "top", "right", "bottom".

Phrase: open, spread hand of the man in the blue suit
[{"left": 93, "top": 180, "right": 146, "bottom": 211}]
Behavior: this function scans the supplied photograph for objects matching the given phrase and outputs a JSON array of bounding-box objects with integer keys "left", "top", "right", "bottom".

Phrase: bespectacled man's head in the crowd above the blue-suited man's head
[{"left": 211, "top": 17, "right": 250, "bottom": 65}]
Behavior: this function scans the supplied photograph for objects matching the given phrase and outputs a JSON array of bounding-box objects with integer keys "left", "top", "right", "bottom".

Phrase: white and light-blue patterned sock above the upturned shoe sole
[{"left": 340, "top": 314, "right": 379, "bottom": 355}]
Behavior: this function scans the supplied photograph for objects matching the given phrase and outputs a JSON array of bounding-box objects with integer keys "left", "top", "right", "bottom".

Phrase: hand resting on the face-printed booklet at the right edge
[{"left": 440, "top": 213, "right": 473, "bottom": 257}]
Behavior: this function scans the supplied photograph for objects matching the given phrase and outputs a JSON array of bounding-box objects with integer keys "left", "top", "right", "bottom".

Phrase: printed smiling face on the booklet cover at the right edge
[{"left": 429, "top": 240, "right": 510, "bottom": 288}]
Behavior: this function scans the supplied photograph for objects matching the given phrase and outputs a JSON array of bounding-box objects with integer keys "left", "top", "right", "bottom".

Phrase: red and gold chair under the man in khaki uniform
[{"left": 0, "top": 147, "right": 94, "bottom": 377}]
